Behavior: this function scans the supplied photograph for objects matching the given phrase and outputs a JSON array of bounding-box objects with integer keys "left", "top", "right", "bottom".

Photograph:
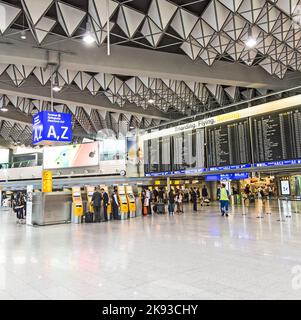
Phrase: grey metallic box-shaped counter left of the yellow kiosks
[{"left": 32, "top": 191, "right": 72, "bottom": 226}]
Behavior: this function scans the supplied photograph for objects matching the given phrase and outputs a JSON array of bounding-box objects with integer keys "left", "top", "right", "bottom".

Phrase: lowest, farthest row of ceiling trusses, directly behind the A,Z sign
[{"left": 0, "top": 91, "right": 161, "bottom": 145}]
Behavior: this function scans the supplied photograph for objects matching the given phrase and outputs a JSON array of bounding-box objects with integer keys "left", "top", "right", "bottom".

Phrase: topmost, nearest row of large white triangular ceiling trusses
[{"left": 0, "top": 0, "right": 301, "bottom": 79}]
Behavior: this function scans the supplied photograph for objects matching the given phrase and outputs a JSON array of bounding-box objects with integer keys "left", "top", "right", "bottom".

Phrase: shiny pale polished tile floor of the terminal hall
[{"left": 0, "top": 201, "right": 301, "bottom": 299}]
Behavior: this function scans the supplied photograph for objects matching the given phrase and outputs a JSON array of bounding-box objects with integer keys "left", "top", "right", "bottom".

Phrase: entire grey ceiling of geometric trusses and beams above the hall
[{"left": 0, "top": 0, "right": 301, "bottom": 146}]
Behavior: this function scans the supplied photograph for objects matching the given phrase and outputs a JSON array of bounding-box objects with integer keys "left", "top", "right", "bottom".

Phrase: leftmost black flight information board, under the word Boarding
[{"left": 144, "top": 129, "right": 205, "bottom": 173}]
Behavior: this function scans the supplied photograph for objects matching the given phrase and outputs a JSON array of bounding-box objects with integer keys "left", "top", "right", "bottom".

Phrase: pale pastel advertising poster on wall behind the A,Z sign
[{"left": 44, "top": 142, "right": 99, "bottom": 169}]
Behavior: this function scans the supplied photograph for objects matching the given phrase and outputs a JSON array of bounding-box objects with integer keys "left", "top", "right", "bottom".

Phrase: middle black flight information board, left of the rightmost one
[{"left": 207, "top": 119, "right": 251, "bottom": 167}]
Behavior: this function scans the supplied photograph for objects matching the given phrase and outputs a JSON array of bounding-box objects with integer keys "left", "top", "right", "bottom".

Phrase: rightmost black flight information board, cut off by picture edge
[{"left": 252, "top": 108, "right": 301, "bottom": 163}]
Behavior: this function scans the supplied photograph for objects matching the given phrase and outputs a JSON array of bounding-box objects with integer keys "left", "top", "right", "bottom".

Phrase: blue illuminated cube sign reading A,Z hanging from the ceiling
[{"left": 32, "top": 111, "right": 72, "bottom": 144}]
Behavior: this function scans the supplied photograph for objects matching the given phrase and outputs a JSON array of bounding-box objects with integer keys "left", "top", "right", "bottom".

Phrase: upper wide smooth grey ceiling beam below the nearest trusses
[{"left": 0, "top": 35, "right": 297, "bottom": 90}]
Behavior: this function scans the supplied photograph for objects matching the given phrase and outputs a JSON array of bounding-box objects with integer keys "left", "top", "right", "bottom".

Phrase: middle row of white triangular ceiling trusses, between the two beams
[{"left": 0, "top": 65, "right": 268, "bottom": 115}]
